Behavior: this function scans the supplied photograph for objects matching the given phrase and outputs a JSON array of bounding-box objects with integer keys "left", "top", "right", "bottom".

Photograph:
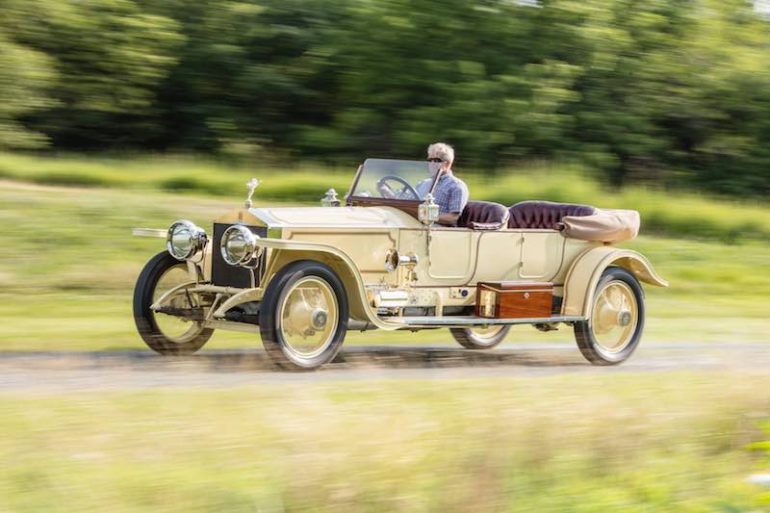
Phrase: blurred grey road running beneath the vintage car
[{"left": 0, "top": 343, "right": 770, "bottom": 392}]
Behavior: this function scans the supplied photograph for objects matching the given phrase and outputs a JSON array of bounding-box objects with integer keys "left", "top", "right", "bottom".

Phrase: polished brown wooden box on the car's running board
[{"left": 476, "top": 281, "right": 553, "bottom": 319}]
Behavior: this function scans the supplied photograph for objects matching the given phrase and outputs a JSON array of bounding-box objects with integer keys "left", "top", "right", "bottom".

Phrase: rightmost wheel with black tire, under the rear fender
[{"left": 574, "top": 267, "right": 644, "bottom": 365}]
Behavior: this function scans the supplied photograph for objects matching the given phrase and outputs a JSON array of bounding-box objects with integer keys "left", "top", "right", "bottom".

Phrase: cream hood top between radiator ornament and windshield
[{"left": 249, "top": 207, "right": 422, "bottom": 228}]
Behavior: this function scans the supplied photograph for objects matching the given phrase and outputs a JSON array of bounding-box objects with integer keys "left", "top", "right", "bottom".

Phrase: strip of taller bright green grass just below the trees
[{"left": 0, "top": 153, "right": 770, "bottom": 243}]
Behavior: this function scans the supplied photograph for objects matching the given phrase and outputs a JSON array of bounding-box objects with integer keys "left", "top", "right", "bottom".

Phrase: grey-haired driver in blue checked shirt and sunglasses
[{"left": 417, "top": 142, "right": 468, "bottom": 226}]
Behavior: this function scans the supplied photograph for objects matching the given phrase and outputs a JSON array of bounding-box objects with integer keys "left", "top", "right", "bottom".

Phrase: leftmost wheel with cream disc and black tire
[{"left": 134, "top": 251, "right": 214, "bottom": 355}]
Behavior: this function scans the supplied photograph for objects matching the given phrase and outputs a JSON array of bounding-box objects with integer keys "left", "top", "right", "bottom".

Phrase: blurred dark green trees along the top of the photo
[{"left": 0, "top": 0, "right": 770, "bottom": 195}]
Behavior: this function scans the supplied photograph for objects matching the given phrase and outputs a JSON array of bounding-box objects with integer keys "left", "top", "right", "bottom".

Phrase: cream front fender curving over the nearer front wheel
[{"left": 257, "top": 239, "right": 402, "bottom": 330}]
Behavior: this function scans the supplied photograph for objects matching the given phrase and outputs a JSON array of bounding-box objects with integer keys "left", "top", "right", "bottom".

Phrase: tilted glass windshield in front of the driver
[{"left": 350, "top": 159, "right": 433, "bottom": 200}]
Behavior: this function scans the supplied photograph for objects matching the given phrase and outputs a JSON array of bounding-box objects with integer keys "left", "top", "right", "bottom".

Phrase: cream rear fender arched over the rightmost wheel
[{"left": 562, "top": 246, "right": 668, "bottom": 318}]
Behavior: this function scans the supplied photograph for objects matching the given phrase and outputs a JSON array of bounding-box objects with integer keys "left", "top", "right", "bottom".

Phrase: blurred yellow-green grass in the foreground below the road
[{"left": 0, "top": 374, "right": 770, "bottom": 513}]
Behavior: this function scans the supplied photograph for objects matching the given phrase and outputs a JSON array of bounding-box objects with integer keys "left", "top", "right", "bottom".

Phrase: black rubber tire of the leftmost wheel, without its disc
[{"left": 134, "top": 251, "right": 214, "bottom": 355}]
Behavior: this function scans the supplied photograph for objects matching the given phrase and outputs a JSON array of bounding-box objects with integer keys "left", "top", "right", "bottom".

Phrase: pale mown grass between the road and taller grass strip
[{"left": 0, "top": 178, "right": 770, "bottom": 350}]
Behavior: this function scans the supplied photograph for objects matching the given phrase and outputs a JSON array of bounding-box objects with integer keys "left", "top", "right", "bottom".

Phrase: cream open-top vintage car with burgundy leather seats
[{"left": 134, "top": 159, "right": 667, "bottom": 369}]
